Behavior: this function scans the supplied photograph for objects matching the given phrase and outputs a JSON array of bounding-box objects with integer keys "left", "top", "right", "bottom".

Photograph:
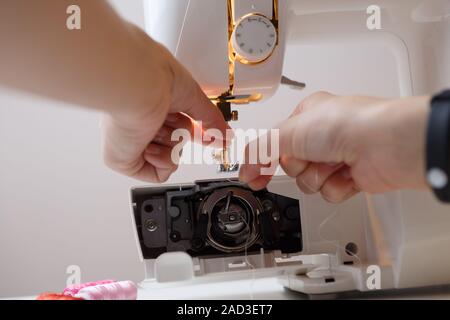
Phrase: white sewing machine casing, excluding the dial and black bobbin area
[{"left": 135, "top": 0, "right": 450, "bottom": 294}]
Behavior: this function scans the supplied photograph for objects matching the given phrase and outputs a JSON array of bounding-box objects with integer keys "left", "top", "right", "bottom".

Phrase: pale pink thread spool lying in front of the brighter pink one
[{"left": 74, "top": 281, "right": 137, "bottom": 300}]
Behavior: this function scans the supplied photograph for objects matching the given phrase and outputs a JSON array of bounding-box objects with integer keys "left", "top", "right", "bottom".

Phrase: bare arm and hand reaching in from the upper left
[{"left": 0, "top": 0, "right": 228, "bottom": 182}]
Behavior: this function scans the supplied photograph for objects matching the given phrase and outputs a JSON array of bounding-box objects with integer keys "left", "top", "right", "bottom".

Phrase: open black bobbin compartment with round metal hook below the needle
[{"left": 131, "top": 179, "right": 310, "bottom": 279}]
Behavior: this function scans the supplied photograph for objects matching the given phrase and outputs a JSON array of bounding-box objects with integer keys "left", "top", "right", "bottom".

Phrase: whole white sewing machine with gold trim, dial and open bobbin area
[{"left": 132, "top": 0, "right": 450, "bottom": 297}]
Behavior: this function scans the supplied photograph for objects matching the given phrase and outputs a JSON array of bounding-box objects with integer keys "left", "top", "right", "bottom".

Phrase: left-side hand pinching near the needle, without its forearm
[{"left": 102, "top": 39, "right": 229, "bottom": 182}]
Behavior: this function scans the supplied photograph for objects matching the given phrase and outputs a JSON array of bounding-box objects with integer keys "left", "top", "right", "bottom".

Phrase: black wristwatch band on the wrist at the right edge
[{"left": 426, "top": 90, "right": 450, "bottom": 202}]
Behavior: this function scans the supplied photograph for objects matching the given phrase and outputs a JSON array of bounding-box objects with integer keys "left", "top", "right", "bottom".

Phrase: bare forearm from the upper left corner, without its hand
[{"left": 0, "top": 0, "right": 170, "bottom": 117}]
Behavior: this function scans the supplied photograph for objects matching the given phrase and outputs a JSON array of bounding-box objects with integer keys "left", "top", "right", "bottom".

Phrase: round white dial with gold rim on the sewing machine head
[{"left": 231, "top": 14, "right": 277, "bottom": 63}]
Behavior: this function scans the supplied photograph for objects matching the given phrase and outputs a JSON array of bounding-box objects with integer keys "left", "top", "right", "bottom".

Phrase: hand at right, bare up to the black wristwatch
[{"left": 239, "top": 92, "right": 430, "bottom": 203}]
